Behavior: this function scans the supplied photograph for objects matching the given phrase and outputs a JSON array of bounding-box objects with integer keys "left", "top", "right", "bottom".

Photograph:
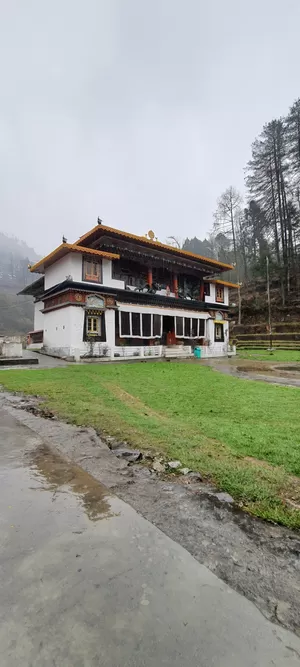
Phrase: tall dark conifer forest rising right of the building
[{"left": 183, "top": 98, "right": 300, "bottom": 306}]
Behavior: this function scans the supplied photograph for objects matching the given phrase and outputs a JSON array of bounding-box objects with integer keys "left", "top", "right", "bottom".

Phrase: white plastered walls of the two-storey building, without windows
[{"left": 27, "top": 252, "right": 233, "bottom": 360}]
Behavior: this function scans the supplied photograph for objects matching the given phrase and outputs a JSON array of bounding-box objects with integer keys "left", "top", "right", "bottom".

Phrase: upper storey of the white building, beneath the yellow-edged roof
[{"left": 27, "top": 243, "right": 228, "bottom": 306}]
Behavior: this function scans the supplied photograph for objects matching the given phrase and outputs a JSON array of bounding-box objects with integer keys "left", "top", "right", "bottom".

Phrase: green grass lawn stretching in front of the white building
[{"left": 0, "top": 363, "right": 300, "bottom": 528}]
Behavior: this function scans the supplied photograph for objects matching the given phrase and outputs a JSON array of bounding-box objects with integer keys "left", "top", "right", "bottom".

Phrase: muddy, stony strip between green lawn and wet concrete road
[{"left": 0, "top": 393, "right": 300, "bottom": 635}]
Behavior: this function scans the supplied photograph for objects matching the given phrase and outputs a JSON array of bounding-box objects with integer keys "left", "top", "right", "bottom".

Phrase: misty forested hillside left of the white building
[{"left": 0, "top": 232, "right": 39, "bottom": 335}]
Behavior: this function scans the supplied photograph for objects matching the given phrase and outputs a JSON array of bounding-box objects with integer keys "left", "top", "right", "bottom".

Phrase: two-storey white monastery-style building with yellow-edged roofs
[{"left": 21, "top": 224, "right": 236, "bottom": 360}]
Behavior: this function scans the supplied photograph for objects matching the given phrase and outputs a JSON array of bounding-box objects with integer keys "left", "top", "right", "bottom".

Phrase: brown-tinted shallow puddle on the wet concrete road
[{"left": 28, "top": 445, "right": 116, "bottom": 521}]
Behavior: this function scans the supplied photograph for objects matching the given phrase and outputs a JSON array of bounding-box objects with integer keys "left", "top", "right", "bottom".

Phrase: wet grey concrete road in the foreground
[{"left": 0, "top": 410, "right": 300, "bottom": 667}]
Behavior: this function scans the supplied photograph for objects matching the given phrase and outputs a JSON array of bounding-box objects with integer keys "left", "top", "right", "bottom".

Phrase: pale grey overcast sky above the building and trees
[{"left": 0, "top": 0, "right": 300, "bottom": 253}]
